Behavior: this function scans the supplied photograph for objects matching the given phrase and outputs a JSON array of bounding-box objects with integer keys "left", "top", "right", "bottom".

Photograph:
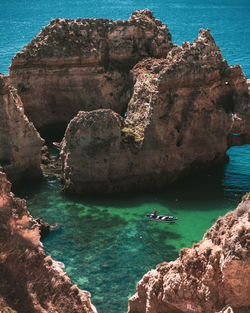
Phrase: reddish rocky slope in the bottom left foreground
[{"left": 0, "top": 172, "right": 97, "bottom": 313}]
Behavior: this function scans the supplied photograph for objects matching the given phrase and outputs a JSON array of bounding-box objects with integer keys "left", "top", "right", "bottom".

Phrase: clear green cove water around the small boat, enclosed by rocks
[{"left": 15, "top": 145, "right": 250, "bottom": 313}]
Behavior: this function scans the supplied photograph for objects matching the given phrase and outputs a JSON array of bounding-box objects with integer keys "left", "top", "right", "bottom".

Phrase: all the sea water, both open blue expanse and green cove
[{"left": 0, "top": 0, "right": 250, "bottom": 313}]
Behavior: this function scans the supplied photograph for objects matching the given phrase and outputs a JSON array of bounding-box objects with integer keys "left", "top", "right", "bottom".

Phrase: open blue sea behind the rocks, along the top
[{"left": 0, "top": 0, "right": 250, "bottom": 78}]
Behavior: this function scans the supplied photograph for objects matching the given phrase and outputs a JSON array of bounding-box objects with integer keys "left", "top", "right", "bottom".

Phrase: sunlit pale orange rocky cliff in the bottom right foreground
[{"left": 128, "top": 194, "right": 250, "bottom": 313}]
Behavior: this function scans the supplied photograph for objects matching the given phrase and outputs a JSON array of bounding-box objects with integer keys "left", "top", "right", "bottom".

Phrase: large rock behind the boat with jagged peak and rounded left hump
[{"left": 62, "top": 29, "right": 250, "bottom": 193}]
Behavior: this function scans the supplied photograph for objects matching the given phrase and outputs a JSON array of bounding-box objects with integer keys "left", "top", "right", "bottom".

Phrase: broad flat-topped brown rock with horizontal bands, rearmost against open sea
[{"left": 10, "top": 10, "right": 173, "bottom": 128}]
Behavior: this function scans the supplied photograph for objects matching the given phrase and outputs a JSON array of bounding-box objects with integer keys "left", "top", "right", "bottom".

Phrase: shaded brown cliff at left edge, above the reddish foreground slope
[{"left": 0, "top": 74, "right": 43, "bottom": 182}]
